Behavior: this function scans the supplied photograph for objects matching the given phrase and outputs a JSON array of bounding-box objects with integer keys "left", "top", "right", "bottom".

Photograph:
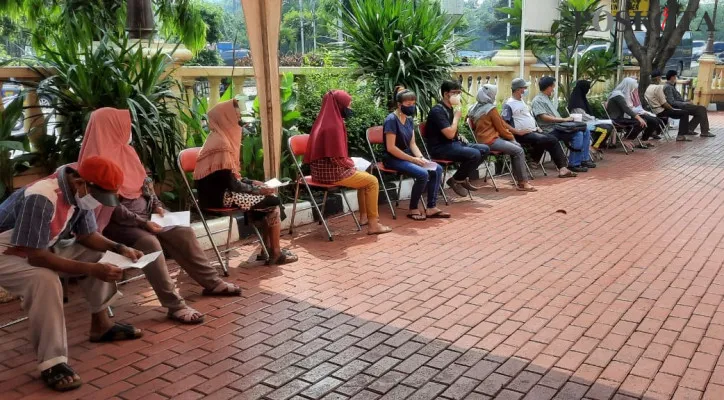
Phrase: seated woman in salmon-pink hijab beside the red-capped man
[{"left": 78, "top": 108, "right": 241, "bottom": 324}]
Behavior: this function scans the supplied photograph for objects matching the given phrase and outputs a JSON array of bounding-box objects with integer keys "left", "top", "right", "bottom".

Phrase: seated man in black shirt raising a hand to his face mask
[{"left": 425, "top": 81, "right": 490, "bottom": 196}]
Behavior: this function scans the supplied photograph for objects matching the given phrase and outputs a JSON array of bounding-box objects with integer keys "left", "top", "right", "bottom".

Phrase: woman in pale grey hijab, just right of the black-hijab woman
[{"left": 606, "top": 78, "right": 662, "bottom": 148}]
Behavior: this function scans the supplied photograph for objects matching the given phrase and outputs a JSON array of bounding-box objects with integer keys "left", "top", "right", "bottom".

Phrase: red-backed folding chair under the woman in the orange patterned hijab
[{"left": 178, "top": 147, "right": 269, "bottom": 276}]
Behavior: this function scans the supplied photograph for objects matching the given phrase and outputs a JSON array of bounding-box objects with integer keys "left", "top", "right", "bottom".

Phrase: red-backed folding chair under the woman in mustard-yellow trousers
[{"left": 287, "top": 134, "right": 362, "bottom": 242}]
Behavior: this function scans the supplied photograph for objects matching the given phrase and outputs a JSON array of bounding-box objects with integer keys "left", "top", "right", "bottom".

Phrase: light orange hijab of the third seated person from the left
[{"left": 194, "top": 100, "right": 241, "bottom": 180}]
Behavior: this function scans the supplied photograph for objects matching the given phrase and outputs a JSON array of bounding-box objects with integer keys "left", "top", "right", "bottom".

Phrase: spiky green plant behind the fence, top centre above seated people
[{"left": 342, "top": 0, "right": 467, "bottom": 115}]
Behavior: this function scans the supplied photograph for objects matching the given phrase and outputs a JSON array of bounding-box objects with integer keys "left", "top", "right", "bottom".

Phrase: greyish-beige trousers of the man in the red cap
[{"left": 0, "top": 244, "right": 120, "bottom": 371}]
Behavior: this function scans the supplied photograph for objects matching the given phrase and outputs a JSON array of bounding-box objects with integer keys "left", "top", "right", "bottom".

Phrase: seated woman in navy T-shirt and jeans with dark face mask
[{"left": 383, "top": 86, "right": 450, "bottom": 221}]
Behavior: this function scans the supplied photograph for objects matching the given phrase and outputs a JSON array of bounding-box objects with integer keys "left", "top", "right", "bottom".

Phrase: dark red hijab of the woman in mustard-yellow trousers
[{"left": 304, "top": 90, "right": 352, "bottom": 164}]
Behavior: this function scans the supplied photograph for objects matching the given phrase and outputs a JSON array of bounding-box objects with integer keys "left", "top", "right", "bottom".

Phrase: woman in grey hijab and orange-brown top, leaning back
[{"left": 468, "top": 84, "right": 536, "bottom": 192}]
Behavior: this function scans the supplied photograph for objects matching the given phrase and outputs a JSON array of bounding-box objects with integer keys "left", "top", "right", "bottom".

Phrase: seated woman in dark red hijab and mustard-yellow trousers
[{"left": 304, "top": 90, "right": 392, "bottom": 235}]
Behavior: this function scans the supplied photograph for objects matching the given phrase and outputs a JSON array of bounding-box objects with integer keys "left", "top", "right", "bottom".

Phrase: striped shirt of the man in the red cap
[{"left": 0, "top": 166, "right": 98, "bottom": 254}]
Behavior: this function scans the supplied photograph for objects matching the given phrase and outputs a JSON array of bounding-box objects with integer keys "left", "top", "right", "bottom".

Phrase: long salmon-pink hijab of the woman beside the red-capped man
[{"left": 78, "top": 107, "right": 146, "bottom": 232}]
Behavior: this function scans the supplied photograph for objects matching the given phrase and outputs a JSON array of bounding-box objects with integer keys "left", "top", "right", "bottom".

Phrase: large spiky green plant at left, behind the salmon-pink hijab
[{"left": 25, "top": 35, "right": 183, "bottom": 188}]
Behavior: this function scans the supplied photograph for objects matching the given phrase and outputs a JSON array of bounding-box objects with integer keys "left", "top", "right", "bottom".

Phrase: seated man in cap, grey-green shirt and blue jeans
[{"left": 531, "top": 76, "right": 596, "bottom": 172}]
